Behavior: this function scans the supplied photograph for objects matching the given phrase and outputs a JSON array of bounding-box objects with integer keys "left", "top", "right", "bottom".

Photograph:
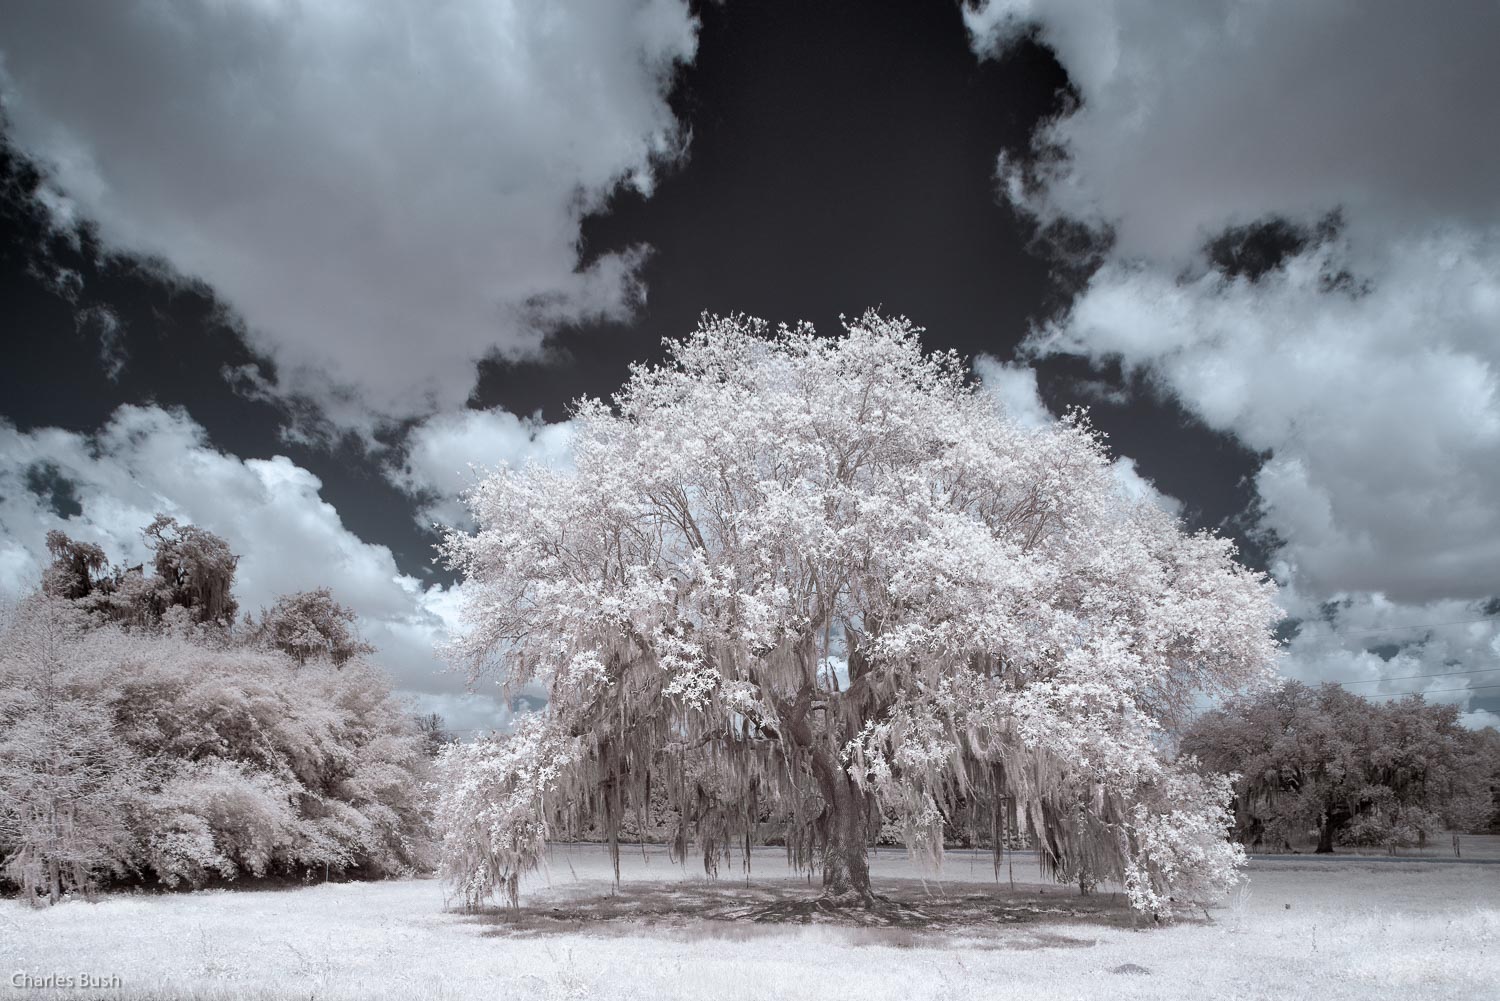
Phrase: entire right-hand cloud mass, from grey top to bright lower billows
[{"left": 966, "top": 0, "right": 1500, "bottom": 720}]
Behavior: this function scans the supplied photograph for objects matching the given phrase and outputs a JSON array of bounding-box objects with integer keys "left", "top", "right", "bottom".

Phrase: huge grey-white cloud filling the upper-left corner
[{"left": 0, "top": 0, "right": 696, "bottom": 425}]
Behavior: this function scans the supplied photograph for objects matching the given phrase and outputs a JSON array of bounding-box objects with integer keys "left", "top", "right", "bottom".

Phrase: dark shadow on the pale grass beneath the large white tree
[{"left": 456, "top": 879, "right": 1151, "bottom": 948}]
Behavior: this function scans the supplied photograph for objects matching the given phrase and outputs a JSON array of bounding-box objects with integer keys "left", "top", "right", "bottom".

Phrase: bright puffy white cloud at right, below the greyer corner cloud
[{"left": 1034, "top": 233, "right": 1500, "bottom": 602}]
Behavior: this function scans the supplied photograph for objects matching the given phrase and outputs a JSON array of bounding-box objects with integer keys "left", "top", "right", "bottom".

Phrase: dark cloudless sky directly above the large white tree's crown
[{"left": 486, "top": 0, "right": 1259, "bottom": 561}]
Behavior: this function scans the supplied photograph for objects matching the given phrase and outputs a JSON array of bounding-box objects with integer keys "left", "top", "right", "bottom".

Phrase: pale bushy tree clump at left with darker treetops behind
[{"left": 0, "top": 519, "right": 441, "bottom": 900}]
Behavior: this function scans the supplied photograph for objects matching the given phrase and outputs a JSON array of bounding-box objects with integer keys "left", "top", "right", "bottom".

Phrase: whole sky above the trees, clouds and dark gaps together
[{"left": 0, "top": 0, "right": 1500, "bottom": 720}]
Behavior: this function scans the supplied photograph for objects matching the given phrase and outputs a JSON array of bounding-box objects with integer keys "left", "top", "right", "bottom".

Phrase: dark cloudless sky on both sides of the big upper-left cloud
[{"left": 0, "top": 0, "right": 1250, "bottom": 573}]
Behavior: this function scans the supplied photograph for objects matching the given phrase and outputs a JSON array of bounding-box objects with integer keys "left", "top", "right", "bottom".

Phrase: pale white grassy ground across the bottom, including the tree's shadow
[{"left": 0, "top": 845, "right": 1500, "bottom": 1001}]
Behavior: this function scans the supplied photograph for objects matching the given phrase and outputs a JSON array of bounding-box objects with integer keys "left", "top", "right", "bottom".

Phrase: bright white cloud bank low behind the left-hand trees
[{"left": 0, "top": 407, "right": 509, "bottom": 728}]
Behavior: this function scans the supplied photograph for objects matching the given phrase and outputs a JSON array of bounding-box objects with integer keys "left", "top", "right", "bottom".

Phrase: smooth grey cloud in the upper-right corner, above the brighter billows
[{"left": 965, "top": 0, "right": 1500, "bottom": 258}]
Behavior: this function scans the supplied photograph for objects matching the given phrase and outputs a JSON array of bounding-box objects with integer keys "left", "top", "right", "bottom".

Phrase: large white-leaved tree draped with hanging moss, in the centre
[{"left": 440, "top": 314, "right": 1277, "bottom": 909}]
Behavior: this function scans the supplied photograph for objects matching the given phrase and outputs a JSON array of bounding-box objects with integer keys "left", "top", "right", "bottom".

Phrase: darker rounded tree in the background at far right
[{"left": 1182, "top": 681, "right": 1500, "bottom": 852}]
